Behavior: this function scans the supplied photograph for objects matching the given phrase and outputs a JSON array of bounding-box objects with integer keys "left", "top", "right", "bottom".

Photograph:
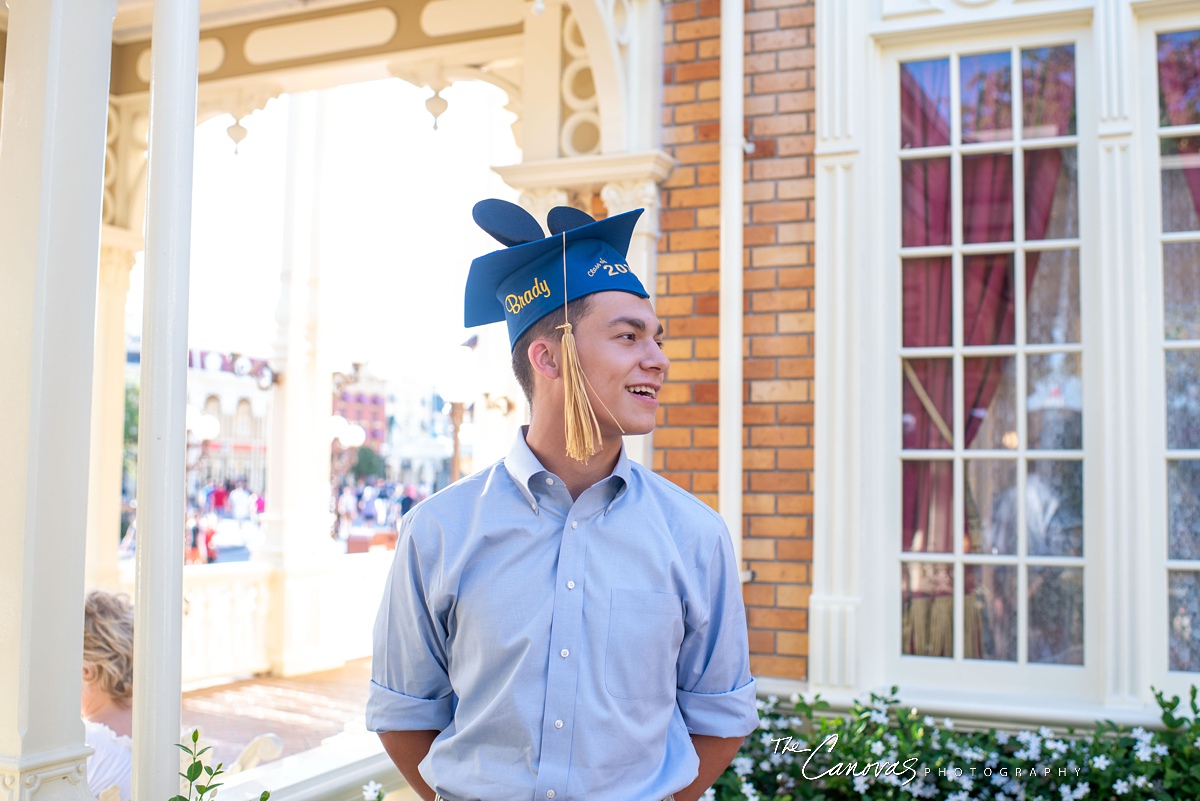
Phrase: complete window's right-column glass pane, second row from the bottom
[{"left": 1025, "top": 459, "right": 1084, "bottom": 556}]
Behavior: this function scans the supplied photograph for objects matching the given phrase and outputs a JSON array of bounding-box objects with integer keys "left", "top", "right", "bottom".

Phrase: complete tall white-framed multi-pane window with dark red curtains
[{"left": 881, "top": 30, "right": 1103, "bottom": 695}]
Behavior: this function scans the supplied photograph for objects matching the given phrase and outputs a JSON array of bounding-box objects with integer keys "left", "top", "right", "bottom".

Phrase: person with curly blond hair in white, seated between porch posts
[{"left": 80, "top": 590, "right": 133, "bottom": 801}]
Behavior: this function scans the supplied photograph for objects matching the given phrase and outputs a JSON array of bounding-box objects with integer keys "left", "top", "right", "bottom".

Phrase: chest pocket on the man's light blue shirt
[{"left": 605, "top": 590, "right": 683, "bottom": 699}]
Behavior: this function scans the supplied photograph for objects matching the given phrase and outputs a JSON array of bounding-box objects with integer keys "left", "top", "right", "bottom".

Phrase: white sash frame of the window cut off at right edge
[{"left": 1136, "top": 13, "right": 1200, "bottom": 698}]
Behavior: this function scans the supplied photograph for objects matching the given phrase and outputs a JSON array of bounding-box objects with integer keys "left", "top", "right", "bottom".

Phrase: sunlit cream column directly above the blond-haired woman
[{"left": 84, "top": 225, "right": 142, "bottom": 591}]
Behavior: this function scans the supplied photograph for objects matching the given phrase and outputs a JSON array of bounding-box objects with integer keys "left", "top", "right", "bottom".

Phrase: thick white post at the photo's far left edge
[{"left": 0, "top": 0, "right": 115, "bottom": 801}]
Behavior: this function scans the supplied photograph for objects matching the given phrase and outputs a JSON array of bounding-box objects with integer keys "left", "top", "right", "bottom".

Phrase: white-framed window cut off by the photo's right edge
[{"left": 1139, "top": 14, "right": 1200, "bottom": 693}]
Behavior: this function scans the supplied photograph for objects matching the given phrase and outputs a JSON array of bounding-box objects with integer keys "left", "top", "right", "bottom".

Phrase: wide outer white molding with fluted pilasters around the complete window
[{"left": 806, "top": 0, "right": 1200, "bottom": 725}]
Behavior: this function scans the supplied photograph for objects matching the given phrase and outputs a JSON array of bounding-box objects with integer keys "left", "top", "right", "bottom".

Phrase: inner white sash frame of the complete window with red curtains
[{"left": 880, "top": 28, "right": 1103, "bottom": 698}]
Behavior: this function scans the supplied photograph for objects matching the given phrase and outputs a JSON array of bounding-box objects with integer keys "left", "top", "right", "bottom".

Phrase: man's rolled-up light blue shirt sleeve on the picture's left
[{"left": 366, "top": 510, "right": 454, "bottom": 731}]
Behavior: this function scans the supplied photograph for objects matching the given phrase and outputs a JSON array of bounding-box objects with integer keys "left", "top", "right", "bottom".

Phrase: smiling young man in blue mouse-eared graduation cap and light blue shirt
[{"left": 367, "top": 200, "right": 757, "bottom": 801}]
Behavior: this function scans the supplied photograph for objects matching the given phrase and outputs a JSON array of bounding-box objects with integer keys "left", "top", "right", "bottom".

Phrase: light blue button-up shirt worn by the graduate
[{"left": 367, "top": 430, "right": 758, "bottom": 801}]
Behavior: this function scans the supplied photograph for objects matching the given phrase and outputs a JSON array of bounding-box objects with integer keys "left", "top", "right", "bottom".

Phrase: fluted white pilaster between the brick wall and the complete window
[{"left": 809, "top": 2, "right": 873, "bottom": 694}]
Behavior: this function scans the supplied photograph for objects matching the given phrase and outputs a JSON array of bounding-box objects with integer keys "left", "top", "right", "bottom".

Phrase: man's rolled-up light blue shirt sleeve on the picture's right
[{"left": 676, "top": 524, "right": 758, "bottom": 737}]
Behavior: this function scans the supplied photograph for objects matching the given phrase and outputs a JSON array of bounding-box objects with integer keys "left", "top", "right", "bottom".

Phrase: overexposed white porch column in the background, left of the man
[{"left": 254, "top": 92, "right": 344, "bottom": 675}]
